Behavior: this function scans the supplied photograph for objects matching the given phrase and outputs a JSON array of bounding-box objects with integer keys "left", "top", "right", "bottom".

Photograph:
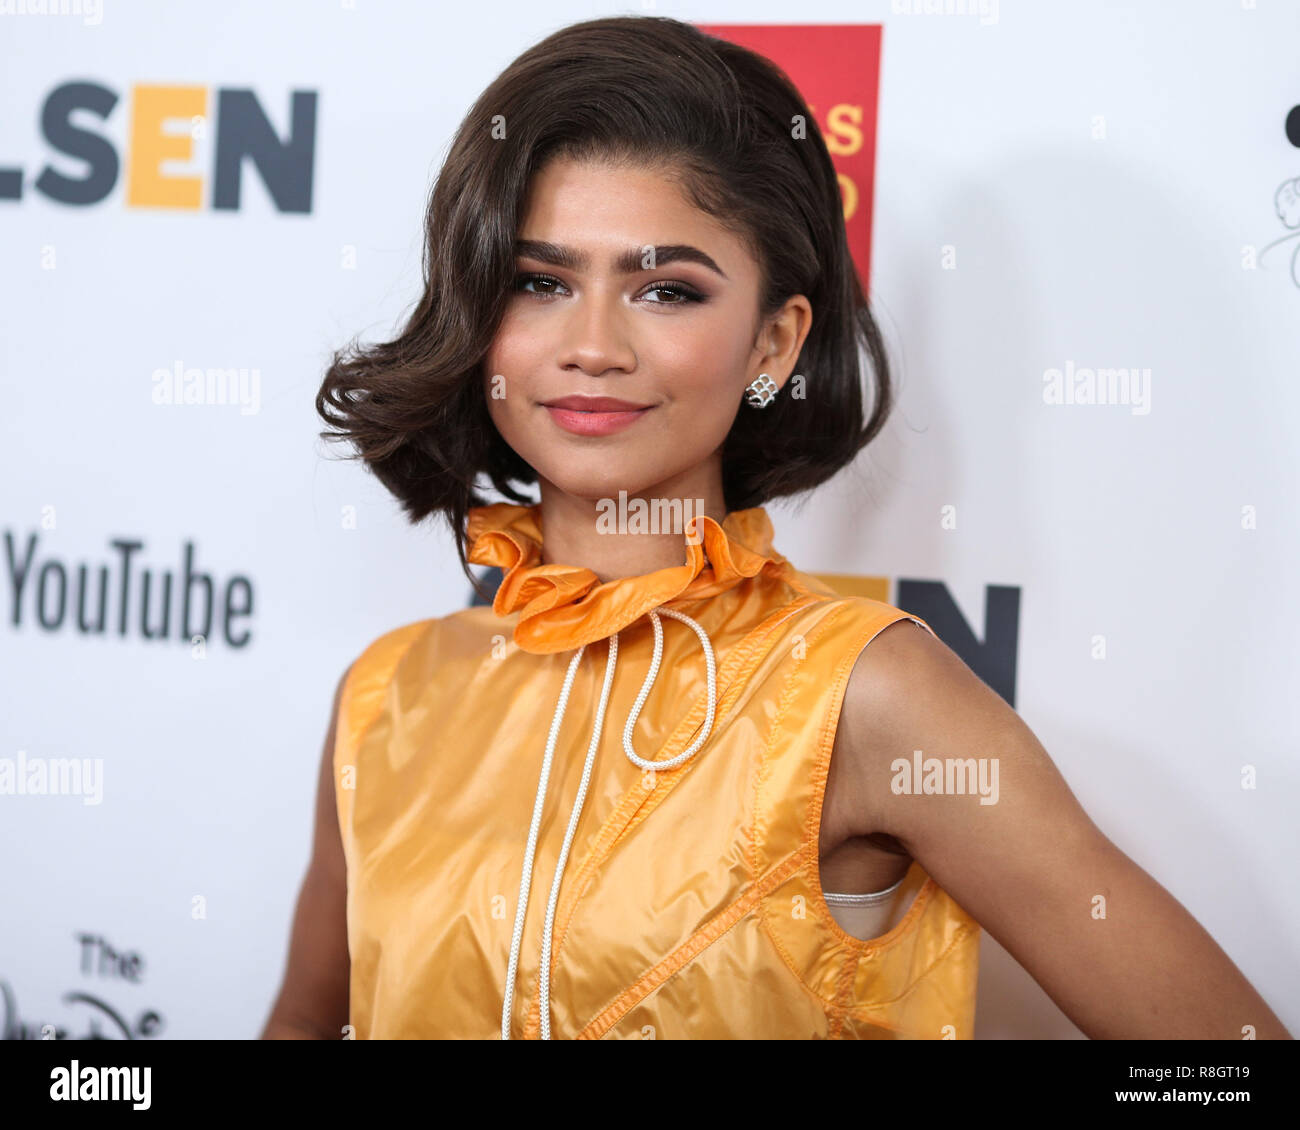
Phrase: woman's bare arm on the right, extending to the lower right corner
[{"left": 833, "top": 620, "right": 1291, "bottom": 1039}]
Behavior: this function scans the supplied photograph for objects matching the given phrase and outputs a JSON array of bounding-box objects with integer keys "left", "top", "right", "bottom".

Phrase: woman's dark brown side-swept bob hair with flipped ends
[{"left": 316, "top": 16, "right": 893, "bottom": 588}]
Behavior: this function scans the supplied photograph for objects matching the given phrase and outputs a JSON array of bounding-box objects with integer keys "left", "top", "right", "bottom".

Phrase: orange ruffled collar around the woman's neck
[{"left": 465, "top": 502, "right": 793, "bottom": 654}]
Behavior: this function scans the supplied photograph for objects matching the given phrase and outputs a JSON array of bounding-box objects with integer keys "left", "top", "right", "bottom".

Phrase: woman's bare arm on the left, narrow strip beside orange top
[{"left": 260, "top": 668, "right": 351, "bottom": 1040}]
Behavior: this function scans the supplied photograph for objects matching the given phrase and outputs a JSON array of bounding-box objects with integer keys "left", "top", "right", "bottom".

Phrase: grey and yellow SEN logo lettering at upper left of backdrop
[{"left": 0, "top": 81, "right": 316, "bottom": 212}]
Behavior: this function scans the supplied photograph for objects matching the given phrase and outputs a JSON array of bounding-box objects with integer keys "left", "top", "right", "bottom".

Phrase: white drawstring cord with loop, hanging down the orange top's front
[{"left": 501, "top": 609, "right": 718, "bottom": 1040}]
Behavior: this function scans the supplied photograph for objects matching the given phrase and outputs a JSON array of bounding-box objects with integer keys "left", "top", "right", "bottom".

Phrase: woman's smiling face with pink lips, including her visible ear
[{"left": 482, "top": 160, "right": 811, "bottom": 508}]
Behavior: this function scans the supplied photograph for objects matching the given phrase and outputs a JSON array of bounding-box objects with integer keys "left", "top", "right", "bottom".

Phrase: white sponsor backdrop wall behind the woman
[{"left": 0, "top": 0, "right": 1300, "bottom": 1038}]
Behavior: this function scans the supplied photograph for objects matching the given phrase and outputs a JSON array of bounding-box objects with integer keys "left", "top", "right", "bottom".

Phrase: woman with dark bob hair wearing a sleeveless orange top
[{"left": 264, "top": 18, "right": 1287, "bottom": 1039}]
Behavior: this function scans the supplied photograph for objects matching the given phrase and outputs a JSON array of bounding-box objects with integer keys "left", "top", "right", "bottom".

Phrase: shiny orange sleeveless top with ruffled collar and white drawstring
[{"left": 334, "top": 503, "right": 979, "bottom": 1039}]
